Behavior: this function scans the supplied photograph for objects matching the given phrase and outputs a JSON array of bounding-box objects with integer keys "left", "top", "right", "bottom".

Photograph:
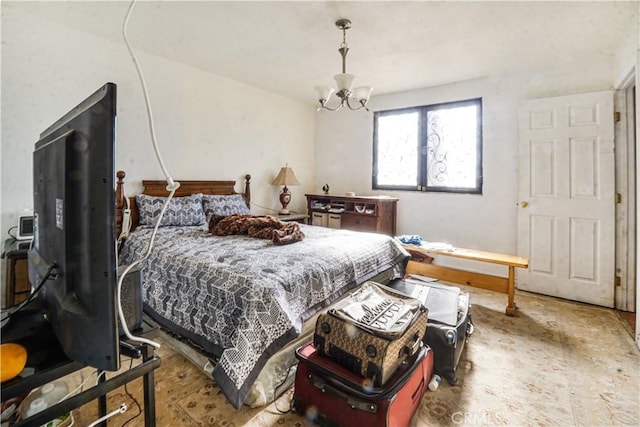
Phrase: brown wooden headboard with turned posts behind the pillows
[{"left": 116, "top": 171, "right": 251, "bottom": 236}]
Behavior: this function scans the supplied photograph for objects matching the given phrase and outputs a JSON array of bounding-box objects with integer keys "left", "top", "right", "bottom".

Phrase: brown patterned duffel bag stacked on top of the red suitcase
[{"left": 313, "top": 282, "right": 428, "bottom": 387}]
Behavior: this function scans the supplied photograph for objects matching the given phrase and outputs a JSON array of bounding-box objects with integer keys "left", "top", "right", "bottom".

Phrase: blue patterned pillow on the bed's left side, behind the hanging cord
[{"left": 136, "top": 194, "right": 205, "bottom": 227}]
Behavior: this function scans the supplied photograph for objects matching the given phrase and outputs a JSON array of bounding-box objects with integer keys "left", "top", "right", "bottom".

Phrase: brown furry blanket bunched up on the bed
[{"left": 209, "top": 214, "right": 304, "bottom": 245}]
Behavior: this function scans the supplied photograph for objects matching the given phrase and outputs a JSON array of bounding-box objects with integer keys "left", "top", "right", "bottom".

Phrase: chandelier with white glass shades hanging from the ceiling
[{"left": 315, "top": 19, "right": 373, "bottom": 111}]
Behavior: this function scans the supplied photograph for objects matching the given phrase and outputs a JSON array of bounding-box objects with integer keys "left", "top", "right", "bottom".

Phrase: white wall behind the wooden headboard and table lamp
[{"left": 0, "top": 2, "right": 316, "bottom": 239}]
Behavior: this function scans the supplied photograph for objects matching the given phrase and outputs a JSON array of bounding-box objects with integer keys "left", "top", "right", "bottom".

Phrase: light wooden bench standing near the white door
[{"left": 403, "top": 245, "right": 529, "bottom": 316}]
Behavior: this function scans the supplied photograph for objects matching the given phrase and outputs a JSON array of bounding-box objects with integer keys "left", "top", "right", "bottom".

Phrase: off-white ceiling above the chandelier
[{"left": 7, "top": 0, "right": 638, "bottom": 102}]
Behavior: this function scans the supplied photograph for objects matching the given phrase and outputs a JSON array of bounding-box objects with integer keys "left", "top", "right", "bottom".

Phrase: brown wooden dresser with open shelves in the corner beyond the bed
[{"left": 305, "top": 194, "right": 398, "bottom": 236}]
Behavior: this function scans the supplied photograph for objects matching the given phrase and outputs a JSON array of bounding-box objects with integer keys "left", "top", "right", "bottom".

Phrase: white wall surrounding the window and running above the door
[{"left": 315, "top": 63, "right": 612, "bottom": 276}]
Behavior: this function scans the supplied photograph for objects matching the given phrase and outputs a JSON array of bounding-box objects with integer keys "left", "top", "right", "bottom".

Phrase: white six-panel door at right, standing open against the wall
[{"left": 517, "top": 92, "right": 615, "bottom": 307}]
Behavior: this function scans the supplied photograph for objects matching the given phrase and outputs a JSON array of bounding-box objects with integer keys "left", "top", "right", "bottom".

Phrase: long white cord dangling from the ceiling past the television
[{"left": 117, "top": 0, "right": 180, "bottom": 349}]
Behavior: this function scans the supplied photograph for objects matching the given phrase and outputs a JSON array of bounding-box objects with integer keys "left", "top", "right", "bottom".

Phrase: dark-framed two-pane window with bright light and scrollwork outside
[{"left": 373, "top": 98, "right": 482, "bottom": 194}]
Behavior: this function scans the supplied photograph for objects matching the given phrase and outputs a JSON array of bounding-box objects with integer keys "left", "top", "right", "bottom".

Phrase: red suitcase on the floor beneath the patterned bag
[{"left": 292, "top": 344, "right": 433, "bottom": 427}]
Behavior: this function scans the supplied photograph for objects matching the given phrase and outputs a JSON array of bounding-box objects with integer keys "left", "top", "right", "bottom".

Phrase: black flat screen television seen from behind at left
[{"left": 28, "top": 83, "right": 120, "bottom": 371}]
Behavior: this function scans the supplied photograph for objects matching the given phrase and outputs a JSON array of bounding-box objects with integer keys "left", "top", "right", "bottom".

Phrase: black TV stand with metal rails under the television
[{"left": 0, "top": 312, "right": 160, "bottom": 427}]
